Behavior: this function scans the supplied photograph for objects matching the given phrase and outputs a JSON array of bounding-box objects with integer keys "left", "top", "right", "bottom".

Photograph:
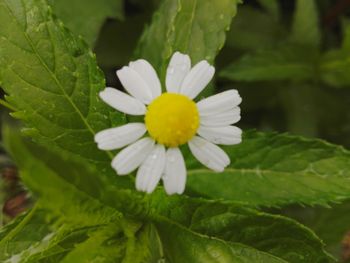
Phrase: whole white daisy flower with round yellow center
[{"left": 95, "top": 52, "right": 242, "bottom": 195}]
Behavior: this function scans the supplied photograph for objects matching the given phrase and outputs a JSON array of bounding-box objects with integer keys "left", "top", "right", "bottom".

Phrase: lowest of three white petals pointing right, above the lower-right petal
[{"left": 198, "top": 126, "right": 242, "bottom": 145}]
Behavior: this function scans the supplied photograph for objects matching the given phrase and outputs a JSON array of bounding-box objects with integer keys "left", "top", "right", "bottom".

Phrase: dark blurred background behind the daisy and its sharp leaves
[{"left": 0, "top": 0, "right": 350, "bottom": 262}]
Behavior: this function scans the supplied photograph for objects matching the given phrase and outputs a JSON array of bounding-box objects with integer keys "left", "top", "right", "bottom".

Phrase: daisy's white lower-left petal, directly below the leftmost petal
[{"left": 112, "top": 138, "right": 155, "bottom": 175}]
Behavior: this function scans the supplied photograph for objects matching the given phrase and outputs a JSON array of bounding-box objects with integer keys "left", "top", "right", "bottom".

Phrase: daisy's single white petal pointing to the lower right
[{"left": 188, "top": 136, "right": 230, "bottom": 172}]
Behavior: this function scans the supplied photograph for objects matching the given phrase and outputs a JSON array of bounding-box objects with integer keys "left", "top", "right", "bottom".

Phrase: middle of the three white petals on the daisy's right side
[{"left": 200, "top": 107, "right": 241, "bottom": 127}]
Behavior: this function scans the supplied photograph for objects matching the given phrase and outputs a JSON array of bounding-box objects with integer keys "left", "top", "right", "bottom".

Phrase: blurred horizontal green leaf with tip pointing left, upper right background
[{"left": 220, "top": 47, "right": 314, "bottom": 81}]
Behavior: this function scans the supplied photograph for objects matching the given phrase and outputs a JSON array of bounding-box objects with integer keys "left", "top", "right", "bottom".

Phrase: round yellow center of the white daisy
[{"left": 145, "top": 93, "right": 199, "bottom": 147}]
